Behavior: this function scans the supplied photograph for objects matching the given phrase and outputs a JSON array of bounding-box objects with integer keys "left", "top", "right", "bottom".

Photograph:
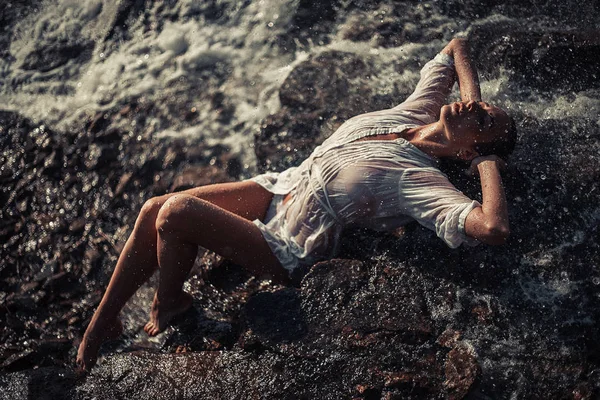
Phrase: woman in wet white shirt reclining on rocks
[{"left": 77, "top": 39, "right": 516, "bottom": 369}]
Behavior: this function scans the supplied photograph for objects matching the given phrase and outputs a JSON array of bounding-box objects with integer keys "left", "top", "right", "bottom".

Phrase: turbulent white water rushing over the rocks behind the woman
[{"left": 0, "top": 0, "right": 600, "bottom": 173}]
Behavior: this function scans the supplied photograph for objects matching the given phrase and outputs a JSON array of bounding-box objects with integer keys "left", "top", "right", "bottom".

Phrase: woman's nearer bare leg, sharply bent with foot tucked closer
[{"left": 144, "top": 194, "right": 288, "bottom": 335}]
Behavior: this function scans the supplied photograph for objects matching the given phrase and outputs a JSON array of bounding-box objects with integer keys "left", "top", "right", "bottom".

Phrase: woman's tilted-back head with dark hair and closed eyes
[{"left": 440, "top": 101, "right": 510, "bottom": 148}]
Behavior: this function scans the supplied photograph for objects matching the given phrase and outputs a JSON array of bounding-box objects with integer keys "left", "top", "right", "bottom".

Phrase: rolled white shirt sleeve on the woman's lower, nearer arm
[{"left": 399, "top": 168, "right": 481, "bottom": 248}]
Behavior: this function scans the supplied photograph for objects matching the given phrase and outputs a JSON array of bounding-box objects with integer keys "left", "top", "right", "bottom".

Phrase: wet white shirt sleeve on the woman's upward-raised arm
[{"left": 394, "top": 53, "right": 456, "bottom": 123}]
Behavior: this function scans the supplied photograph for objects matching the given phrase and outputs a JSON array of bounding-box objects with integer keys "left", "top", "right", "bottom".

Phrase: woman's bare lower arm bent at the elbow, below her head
[{"left": 465, "top": 155, "right": 510, "bottom": 245}]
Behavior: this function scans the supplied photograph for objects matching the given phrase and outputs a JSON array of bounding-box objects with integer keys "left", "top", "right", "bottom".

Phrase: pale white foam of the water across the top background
[{"left": 0, "top": 0, "right": 600, "bottom": 172}]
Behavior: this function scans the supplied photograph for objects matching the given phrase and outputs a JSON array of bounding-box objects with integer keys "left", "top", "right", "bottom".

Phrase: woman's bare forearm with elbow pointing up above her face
[{"left": 442, "top": 39, "right": 481, "bottom": 101}]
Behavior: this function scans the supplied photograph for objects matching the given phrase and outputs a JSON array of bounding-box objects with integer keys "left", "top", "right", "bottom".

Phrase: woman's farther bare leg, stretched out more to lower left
[{"left": 77, "top": 181, "right": 272, "bottom": 369}]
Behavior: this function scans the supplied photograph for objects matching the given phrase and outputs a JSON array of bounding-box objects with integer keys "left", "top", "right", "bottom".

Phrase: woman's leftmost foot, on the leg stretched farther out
[{"left": 76, "top": 318, "right": 123, "bottom": 371}]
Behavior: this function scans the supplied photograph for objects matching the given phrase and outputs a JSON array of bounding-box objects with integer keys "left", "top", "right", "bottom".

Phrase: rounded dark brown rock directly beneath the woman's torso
[{"left": 302, "top": 260, "right": 432, "bottom": 343}]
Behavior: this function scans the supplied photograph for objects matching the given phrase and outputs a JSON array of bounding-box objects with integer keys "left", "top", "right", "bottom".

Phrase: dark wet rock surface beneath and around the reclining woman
[{"left": 0, "top": 1, "right": 600, "bottom": 399}]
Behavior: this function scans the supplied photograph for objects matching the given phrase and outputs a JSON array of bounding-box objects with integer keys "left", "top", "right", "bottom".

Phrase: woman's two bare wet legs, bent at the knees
[{"left": 76, "top": 181, "right": 289, "bottom": 370}]
